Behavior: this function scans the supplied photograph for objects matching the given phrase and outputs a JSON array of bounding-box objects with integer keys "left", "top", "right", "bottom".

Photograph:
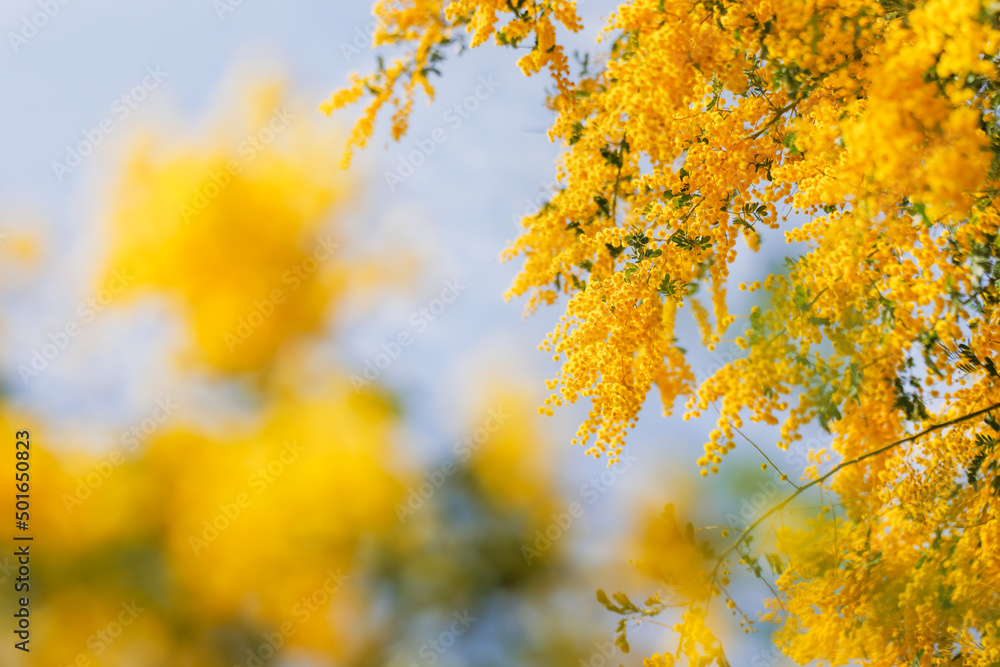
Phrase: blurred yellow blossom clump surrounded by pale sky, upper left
[{"left": 100, "top": 85, "right": 371, "bottom": 372}]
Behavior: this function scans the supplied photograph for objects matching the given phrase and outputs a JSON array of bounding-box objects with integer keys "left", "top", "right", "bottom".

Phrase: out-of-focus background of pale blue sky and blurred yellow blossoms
[{"left": 0, "top": 0, "right": 819, "bottom": 667}]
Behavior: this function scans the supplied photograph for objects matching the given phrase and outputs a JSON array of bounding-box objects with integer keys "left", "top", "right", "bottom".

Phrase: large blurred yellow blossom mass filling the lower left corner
[{"left": 14, "top": 381, "right": 402, "bottom": 665}]
